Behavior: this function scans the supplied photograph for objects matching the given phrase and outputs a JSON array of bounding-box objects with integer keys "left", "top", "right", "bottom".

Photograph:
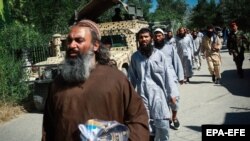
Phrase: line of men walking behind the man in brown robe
[{"left": 128, "top": 23, "right": 234, "bottom": 141}]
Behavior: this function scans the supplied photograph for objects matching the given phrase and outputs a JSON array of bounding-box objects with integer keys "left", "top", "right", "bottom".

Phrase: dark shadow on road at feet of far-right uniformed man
[{"left": 221, "top": 69, "right": 250, "bottom": 97}]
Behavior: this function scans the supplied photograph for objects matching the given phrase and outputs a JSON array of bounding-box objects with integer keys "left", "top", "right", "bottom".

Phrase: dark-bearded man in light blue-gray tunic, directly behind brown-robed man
[{"left": 128, "top": 28, "right": 177, "bottom": 141}]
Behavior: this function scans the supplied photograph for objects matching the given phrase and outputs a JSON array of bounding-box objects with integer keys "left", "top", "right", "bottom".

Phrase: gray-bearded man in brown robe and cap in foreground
[{"left": 42, "top": 20, "right": 149, "bottom": 141}]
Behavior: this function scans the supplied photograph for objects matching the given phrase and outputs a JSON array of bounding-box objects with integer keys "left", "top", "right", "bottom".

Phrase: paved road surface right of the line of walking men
[{"left": 170, "top": 50, "right": 250, "bottom": 141}]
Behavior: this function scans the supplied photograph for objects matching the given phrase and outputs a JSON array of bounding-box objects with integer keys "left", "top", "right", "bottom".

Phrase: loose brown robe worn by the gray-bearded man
[{"left": 42, "top": 65, "right": 149, "bottom": 141}]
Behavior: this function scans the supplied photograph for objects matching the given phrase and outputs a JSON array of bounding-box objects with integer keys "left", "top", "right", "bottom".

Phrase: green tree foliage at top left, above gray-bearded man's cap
[{"left": 11, "top": 0, "right": 86, "bottom": 34}]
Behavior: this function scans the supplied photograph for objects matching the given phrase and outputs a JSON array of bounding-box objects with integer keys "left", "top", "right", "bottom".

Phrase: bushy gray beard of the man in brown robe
[{"left": 61, "top": 51, "right": 95, "bottom": 83}]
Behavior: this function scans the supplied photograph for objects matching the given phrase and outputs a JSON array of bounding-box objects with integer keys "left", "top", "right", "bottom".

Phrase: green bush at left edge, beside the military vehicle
[{"left": 0, "top": 23, "right": 48, "bottom": 103}]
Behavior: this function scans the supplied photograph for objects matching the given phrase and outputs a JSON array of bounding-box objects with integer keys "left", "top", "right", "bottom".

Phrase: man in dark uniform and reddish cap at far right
[{"left": 227, "top": 22, "right": 248, "bottom": 78}]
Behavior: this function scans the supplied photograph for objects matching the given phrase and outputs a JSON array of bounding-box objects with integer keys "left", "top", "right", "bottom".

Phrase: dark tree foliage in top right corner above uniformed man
[{"left": 189, "top": 0, "right": 250, "bottom": 31}]
